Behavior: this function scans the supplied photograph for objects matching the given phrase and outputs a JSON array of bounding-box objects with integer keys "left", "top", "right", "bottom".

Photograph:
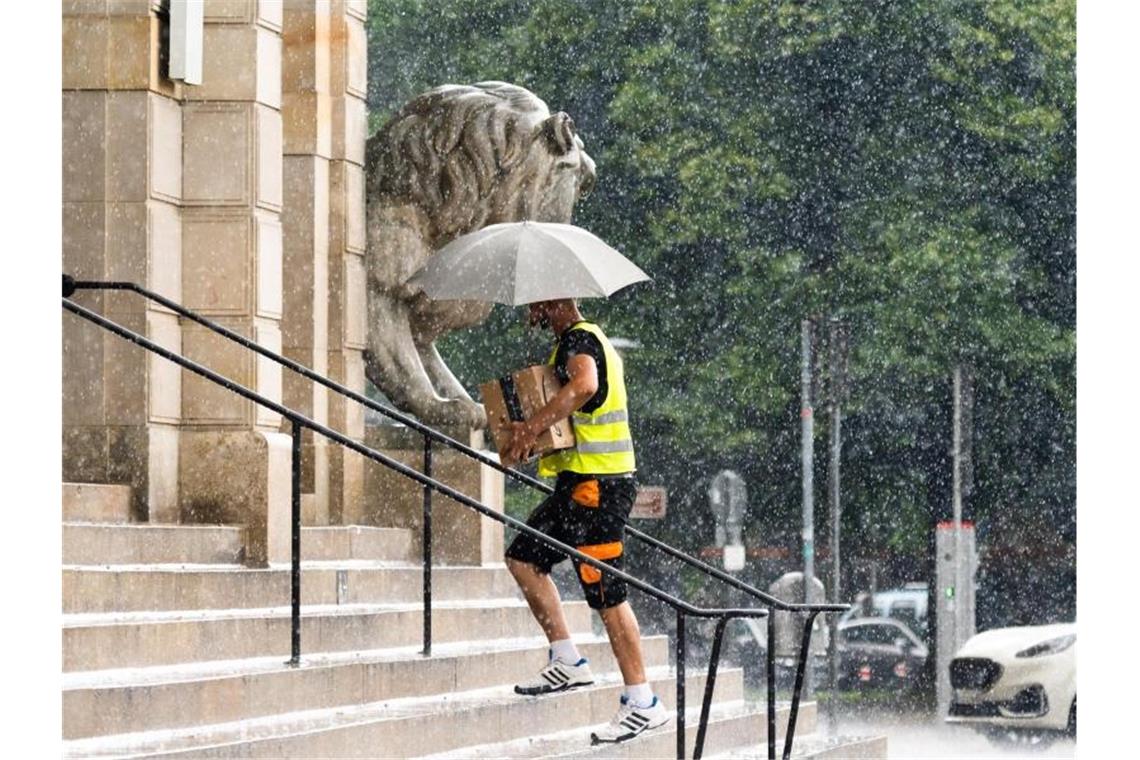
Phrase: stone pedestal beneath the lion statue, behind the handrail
[{"left": 362, "top": 426, "right": 504, "bottom": 565}]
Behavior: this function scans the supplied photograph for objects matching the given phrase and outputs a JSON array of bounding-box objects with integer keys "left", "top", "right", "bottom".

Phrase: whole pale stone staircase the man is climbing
[{"left": 63, "top": 484, "right": 886, "bottom": 758}]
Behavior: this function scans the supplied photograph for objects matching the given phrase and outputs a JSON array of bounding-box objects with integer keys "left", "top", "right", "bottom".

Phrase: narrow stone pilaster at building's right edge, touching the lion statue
[{"left": 328, "top": 0, "right": 368, "bottom": 524}]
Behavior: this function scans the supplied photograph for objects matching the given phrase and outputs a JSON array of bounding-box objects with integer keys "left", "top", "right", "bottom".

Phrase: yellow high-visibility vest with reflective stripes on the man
[{"left": 538, "top": 321, "right": 637, "bottom": 477}]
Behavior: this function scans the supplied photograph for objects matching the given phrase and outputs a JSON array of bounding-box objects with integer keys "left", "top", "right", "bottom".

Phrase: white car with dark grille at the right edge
[{"left": 946, "top": 623, "right": 1076, "bottom": 744}]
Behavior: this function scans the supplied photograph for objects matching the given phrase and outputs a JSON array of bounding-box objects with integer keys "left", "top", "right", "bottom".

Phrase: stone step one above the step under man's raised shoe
[{"left": 63, "top": 598, "right": 592, "bottom": 672}]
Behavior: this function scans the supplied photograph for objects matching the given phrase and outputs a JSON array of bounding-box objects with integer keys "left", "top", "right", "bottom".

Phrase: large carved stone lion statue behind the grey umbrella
[{"left": 365, "top": 82, "right": 595, "bottom": 428}]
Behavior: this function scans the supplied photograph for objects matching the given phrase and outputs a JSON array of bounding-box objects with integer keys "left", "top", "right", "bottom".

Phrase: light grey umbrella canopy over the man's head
[{"left": 408, "top": 221, "right": 650, "bottom": 307}]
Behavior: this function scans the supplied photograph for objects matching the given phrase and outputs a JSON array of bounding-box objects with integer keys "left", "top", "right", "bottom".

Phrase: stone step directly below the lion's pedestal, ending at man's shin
[{"left": 63, "top": 561, "right": 518, "bottom": 613}]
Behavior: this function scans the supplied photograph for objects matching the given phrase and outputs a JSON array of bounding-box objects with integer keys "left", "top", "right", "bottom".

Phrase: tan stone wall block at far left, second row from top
[{"left": 63, "top": 91, "right": 107, "bottom": 202}]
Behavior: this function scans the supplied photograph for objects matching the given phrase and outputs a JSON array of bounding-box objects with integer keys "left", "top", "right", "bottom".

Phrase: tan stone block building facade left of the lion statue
[{"left": 63, "top": 0, "right": 367, "bottom": 565}]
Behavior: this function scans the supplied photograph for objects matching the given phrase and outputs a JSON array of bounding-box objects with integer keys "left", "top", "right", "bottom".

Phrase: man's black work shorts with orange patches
[{"left": 506, "top": 472, "right": 637, "bottom": 610}]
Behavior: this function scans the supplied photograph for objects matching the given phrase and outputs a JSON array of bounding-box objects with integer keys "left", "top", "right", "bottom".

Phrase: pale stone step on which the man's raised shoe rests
[{"left": 63, "top": 635, "right": 670, "bottom": 739}]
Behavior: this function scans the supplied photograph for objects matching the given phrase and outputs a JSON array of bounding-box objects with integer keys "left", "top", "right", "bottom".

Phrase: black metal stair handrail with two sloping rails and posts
[{"left": 63, "top": 275, "right": 849, "bottom": 760}]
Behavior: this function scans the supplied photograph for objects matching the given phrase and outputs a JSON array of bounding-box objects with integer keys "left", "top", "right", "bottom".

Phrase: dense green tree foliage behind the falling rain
[{"left": 369, "top": 0, "right": 1076, "bottom": 619}]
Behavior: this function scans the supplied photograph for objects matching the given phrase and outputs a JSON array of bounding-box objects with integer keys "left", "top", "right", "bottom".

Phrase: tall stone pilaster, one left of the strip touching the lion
[{"left": 282, "top": 0, "right": 336, "bottom": 525}]
